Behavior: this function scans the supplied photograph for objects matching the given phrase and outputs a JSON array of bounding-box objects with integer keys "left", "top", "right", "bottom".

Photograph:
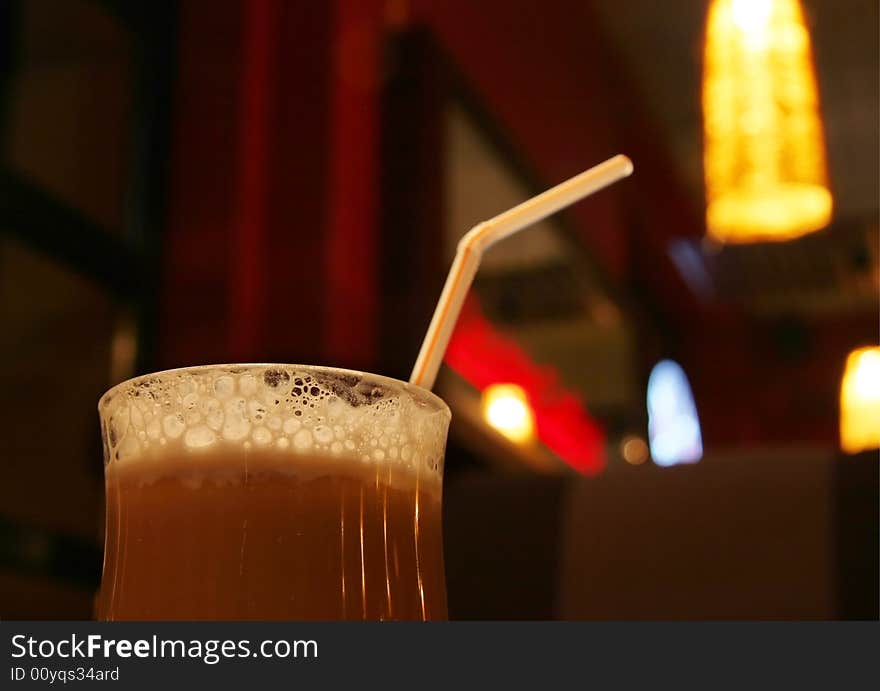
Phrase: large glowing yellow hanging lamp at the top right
[{"left": 703, "top": 0, "right": 832, "bottom": 242}]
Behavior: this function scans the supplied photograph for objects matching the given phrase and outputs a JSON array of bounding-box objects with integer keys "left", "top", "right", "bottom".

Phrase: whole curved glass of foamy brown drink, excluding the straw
[{"left": 97, "top": 364, "right": 450, "bottom": 621}]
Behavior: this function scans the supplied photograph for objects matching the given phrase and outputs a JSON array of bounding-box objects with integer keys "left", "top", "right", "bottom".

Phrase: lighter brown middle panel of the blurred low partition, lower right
[{"left": 558, "top": 448, "right": 841, "bottom": 619}]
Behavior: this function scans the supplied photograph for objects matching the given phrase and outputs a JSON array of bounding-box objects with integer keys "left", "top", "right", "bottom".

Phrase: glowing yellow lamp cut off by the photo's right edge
[{"left": 840, "top": 346, "right": 880, "bottom": 453}]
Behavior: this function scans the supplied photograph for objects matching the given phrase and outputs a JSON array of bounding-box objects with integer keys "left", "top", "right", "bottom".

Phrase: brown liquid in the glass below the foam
[{"left": 98, "top": 449, "right": 447, "bottom": 620}]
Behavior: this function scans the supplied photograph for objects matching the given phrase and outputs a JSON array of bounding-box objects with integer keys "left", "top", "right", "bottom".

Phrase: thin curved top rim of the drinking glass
[{"left": 98, "top": 362, "right": 452, "bottom": 417}]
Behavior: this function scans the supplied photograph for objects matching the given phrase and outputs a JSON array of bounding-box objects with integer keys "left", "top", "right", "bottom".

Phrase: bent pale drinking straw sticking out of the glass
[{"left": 409, "top": 155, "right": 633, "bottom": 389}]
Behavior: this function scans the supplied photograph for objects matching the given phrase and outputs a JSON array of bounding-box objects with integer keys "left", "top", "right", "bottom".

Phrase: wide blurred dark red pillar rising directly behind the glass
[{"left": 159, "top": 0, "right": 382, "bottom": 368}]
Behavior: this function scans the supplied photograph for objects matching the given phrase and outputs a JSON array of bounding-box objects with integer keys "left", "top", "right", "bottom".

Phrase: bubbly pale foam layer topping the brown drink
[{"left": 98, "top": 364, "right": 450, "bottom": 474}]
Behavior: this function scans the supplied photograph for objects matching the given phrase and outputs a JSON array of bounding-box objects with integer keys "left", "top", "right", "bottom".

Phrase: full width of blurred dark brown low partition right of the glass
[{"left": 444, "top": 447, "right": 848, "bottom": 620}]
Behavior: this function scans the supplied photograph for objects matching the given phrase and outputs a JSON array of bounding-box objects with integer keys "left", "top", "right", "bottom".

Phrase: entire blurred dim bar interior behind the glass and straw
[{"left": 0, "top": 0, "right": 880, "bottom": 619}]
